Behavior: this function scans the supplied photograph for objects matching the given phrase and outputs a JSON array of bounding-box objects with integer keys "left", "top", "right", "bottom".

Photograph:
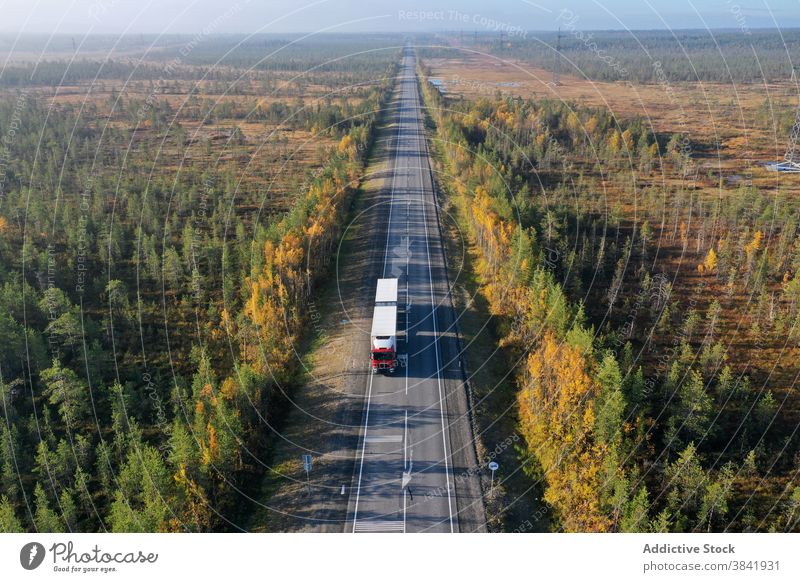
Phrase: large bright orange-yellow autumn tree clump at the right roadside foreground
[{"left": 517, "top": 332, "right": 612, "bottom": 532}]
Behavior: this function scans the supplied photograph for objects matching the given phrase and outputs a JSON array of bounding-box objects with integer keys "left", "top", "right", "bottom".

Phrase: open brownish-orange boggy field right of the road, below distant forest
[{"left": 425, "top": 50, "right": 797, "bottom": 181}]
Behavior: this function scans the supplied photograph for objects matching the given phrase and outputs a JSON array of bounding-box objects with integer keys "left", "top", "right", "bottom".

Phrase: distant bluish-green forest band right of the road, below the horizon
[{"left": 428, "top": 30, "right": 800, "bottom": 83}]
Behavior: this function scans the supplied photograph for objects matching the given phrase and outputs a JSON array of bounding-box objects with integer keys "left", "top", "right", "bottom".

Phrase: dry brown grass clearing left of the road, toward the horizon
[{"left": 0, "top": 73, "right": 360, "bottom": 217}]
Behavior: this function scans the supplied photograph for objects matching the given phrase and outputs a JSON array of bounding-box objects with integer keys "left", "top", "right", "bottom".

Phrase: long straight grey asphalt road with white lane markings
[{"left": 346, "top": 48, "right": 471, "bottom": 533}]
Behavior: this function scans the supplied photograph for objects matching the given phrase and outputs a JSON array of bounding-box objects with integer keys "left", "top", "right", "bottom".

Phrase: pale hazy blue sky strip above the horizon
[{"left": 0, "top": 0, "right": 800, "bottom": 34}]
